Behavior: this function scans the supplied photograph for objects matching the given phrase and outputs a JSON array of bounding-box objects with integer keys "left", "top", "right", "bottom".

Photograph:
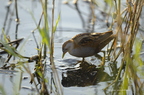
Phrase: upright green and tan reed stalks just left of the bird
[{"left": 31, "top": 0, "right": 63, "bottom": 95}]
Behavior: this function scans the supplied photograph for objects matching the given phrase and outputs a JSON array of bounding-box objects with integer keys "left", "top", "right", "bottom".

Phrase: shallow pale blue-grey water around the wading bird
[{"left": 0, "top": 0, "right": 144, "bottom": 95}]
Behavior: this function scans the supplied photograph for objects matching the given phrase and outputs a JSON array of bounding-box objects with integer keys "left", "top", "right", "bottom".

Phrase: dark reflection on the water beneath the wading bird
[{"left": 61, "top": 61, "right": 112, "bottom": 87}]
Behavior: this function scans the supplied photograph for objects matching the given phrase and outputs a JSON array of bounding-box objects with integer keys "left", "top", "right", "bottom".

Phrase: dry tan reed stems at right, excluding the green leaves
[{"left": 104, "top": 0, "right": 144, "bottom": 93}]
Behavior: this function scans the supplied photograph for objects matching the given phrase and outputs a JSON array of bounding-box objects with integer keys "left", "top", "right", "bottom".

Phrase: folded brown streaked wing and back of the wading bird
[{"left": 72, "top": 31, "right": 112, "bottom": 47}]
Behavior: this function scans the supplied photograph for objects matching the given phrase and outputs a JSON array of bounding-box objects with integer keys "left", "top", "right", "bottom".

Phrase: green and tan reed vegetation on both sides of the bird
[{"left": 0, "top": 0, "right": 144, "bottom": 95}]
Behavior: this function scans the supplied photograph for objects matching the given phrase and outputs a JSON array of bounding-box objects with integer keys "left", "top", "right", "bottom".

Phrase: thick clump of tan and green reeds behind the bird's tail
[{"left": 105, "top": 0, "right": 144, "bottom": 95}]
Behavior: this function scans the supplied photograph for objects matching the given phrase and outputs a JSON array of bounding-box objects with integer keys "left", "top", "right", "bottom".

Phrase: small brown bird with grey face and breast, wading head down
[{"left": 62, "top": 31, "right": 115, "bottom": 60}]
